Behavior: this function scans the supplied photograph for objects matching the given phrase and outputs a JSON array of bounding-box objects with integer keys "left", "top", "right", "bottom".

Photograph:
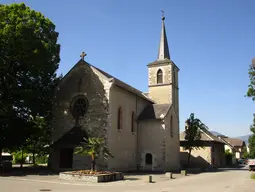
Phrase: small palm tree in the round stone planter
[{"left": 75, "top": 137, "right": 113, "bottom": 171}]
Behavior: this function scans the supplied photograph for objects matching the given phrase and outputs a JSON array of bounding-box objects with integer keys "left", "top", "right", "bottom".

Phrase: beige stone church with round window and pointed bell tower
[{"left": 49, "top": 16, "right": 180, "bottom": 171}]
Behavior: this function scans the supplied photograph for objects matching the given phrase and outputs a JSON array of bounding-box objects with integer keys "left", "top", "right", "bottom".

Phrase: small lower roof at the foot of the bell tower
[{"left": 138, "top": 104, "right": 171, "bottom": 120}]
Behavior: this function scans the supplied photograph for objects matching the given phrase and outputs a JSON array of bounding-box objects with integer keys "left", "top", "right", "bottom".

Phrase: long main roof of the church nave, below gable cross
[{"left": 57, "top": 59, "right": 155, "bottom": 103}]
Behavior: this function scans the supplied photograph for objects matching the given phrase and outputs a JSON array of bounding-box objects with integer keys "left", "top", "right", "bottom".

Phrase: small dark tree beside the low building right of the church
[{"left": 184, "top": 113, "right": 207, "bottom": 166}]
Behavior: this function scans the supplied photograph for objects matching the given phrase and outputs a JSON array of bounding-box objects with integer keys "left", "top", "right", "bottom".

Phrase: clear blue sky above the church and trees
[{"left": 1, "top": 0, "right": 255, "bottom": 137}]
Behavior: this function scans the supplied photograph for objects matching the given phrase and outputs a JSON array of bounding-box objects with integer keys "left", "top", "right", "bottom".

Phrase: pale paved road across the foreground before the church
[{"left": 0, "top": 169, "right": 255, "bottom": 192}]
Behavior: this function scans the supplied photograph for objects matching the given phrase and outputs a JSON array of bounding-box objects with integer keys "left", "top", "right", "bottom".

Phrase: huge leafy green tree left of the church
[{"left": 0, "top": 3, "right": 60, "bottom": 158}]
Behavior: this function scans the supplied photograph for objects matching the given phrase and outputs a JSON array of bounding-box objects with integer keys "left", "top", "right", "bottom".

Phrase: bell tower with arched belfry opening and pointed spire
[{"left": 147, "top": 15, "right": 179, "bottom": 114}]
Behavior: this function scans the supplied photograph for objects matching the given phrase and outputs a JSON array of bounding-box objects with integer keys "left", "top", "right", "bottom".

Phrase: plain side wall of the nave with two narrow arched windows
[{"left": 108, "top": 86, "right": 150, "bottom": 171}]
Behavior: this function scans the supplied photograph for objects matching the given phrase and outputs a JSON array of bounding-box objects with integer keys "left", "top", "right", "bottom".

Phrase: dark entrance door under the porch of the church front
[{"left": 59, "top": 148, "right": 73, "bottom": 168}]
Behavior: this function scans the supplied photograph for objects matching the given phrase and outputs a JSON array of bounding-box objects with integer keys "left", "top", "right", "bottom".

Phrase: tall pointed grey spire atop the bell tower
[{"left": 158, "top": 10, "right": 170, "bottom": 60}]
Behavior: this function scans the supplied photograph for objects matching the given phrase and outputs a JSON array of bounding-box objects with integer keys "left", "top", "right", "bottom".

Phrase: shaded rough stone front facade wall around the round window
[{"left": 51, "top": 61, "right": 111, "bottom": 168}]
